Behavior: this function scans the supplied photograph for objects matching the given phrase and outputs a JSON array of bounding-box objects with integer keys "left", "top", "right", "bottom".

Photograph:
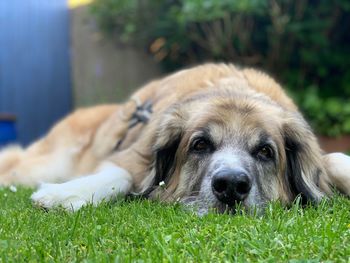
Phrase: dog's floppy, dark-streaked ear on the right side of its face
[{"left": 282, "top": 113, "right": 326, "bottom": 204}]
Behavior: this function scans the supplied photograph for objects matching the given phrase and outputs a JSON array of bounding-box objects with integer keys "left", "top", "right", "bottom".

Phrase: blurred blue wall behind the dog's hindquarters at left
[{"left": 0, "top": 0, "right": 72, "bottom": 144}]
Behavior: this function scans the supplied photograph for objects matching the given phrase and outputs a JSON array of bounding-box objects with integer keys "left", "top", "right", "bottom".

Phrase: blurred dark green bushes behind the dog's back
[{"left": 92, "top": 0, "right": 350, "bottom": 134}]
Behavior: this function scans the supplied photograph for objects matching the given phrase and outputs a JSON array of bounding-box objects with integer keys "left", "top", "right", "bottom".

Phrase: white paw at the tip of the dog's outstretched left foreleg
[{"left": 31, "top": 184, "right": 89, "bottom": 211}]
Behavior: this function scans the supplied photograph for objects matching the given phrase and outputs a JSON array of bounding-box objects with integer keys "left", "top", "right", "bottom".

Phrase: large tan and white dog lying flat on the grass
[{"left": 0, "top": 64, "right": 350, "bottom": 212}]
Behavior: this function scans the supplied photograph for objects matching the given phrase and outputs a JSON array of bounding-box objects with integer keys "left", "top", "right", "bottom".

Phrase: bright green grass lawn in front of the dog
[{"left": 0, "top": 188, "right": 350, "bottom": 262}]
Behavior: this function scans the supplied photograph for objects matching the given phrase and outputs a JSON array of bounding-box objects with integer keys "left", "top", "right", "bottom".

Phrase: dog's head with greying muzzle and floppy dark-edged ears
[{"left": 142, "top": 91, "right": 324, "bottom": 216}]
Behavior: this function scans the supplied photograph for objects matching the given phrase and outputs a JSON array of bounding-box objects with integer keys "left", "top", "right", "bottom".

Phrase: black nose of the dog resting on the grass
[{"left": 211, "top": 169, "right": 252, "bottom": 205}]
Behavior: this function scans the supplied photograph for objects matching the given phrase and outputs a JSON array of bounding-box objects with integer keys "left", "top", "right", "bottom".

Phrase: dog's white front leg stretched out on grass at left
[{"left": 31, "top": 162, "right": 133, "bottom": 211}]
